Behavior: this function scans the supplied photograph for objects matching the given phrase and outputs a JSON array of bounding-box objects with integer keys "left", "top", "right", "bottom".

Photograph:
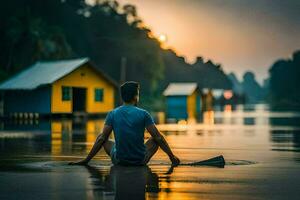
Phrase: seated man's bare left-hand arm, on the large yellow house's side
[{"left": 69, "top": 125, "right": 112, "bottom": 165}]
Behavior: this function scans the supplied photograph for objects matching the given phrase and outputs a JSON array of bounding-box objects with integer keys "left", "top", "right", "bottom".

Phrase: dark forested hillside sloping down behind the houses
[{"left": 0, "top": 0, "right": 231, "bottom": 109}]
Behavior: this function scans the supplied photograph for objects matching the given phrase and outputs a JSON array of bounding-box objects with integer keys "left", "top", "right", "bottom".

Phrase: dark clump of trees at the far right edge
[{"left": 269, "top": 50, "right": 300, "bottom": 108}]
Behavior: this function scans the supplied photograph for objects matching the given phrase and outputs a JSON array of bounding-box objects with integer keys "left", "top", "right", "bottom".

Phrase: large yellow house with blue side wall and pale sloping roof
[{"left": 0, "top": 58, "right": 117, "bottom": 114}]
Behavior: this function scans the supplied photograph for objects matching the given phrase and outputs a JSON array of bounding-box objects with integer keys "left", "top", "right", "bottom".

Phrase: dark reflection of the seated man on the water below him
[{"left": 86, "top": 166, "right": 159, "bottom": 200}]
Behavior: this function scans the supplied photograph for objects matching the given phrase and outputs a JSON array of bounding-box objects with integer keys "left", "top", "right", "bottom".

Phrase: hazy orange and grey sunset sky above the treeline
[{"left": 104, "top": 0, "right": 300, "bottom": 82}]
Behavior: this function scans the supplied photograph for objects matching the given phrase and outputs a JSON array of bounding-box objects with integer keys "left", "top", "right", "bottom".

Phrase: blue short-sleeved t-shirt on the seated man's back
[{"left": 105, "top": 105, "right": 154, "bottom": 164}]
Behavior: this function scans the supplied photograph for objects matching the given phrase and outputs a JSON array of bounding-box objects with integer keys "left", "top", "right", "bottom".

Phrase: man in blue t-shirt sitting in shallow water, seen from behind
[{"left": 70, "top": 81, "right": 180, "bottom": 166}]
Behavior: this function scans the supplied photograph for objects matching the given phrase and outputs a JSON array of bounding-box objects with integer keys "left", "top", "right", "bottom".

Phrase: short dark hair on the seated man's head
[{"left": 120, "top": 81, "right": 140, "bottom": 103}]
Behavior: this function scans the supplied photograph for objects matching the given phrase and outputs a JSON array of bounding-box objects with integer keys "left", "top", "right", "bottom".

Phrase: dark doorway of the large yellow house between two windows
[{"left": 72, "top": 87, "right": 86, "bottom": 112}]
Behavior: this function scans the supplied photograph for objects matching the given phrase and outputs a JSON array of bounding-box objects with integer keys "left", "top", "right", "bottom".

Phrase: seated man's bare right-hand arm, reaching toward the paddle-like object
[{"left": 146, "top": 124, "right": 180, "bottom": 166}]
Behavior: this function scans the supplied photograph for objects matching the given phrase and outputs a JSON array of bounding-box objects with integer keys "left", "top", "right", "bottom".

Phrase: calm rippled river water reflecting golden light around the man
[{"left": 0, "top": 105, "right": 300, "bottom": 199}]
